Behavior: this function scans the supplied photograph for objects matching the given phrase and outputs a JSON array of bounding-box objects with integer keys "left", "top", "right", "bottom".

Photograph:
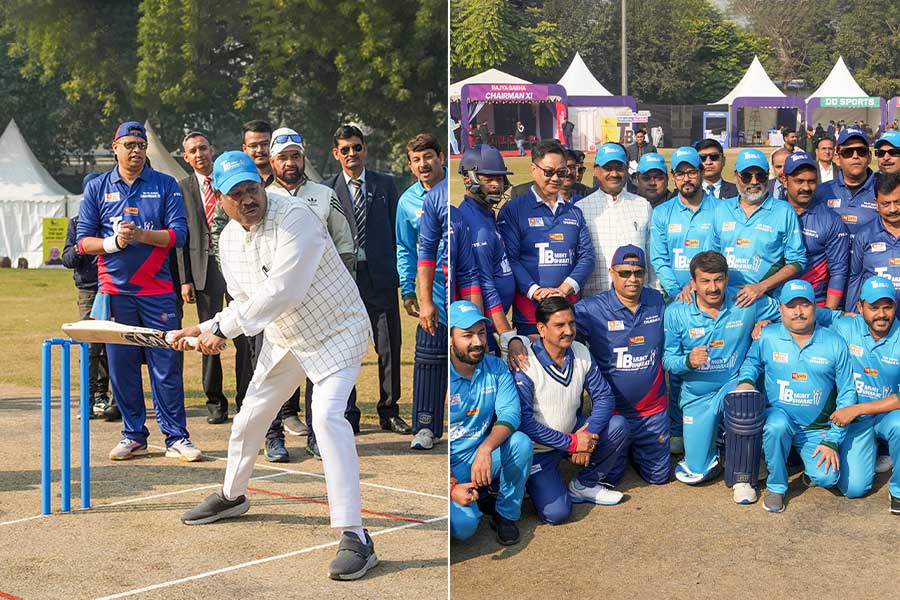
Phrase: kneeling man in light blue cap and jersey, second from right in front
[{"left": 737, "top": 280, "right": 857, "bottom": 512}]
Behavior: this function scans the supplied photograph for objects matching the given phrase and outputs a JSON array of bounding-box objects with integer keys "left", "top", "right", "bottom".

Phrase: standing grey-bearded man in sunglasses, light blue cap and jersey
[{"left": 711, "top": 148, "right": 806, "bottom": 307}]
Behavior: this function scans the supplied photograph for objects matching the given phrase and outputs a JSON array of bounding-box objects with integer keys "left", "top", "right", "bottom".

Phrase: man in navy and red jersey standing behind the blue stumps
[{"left": 76, "top": 121, "right": 202, "bottom": 461}]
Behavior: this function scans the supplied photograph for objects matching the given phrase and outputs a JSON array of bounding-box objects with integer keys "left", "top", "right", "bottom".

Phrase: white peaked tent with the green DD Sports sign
[{"left": 805, "top": 56, "right": 887, "bottom": 130}]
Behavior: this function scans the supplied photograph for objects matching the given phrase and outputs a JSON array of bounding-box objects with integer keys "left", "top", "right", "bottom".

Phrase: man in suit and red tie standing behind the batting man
[{"left": 177, "top": 131, "right": 228, "bottom": 424}]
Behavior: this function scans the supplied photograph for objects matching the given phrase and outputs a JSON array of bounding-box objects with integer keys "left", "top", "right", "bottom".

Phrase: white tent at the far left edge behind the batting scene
[{"left": 0, "top": 120, "right": 71, "bottom": 268}]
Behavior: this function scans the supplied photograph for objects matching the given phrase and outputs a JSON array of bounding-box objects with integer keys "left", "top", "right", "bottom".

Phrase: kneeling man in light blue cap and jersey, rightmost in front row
[{"left": 831, "top": 277, "right": 900, "bottom": 515}]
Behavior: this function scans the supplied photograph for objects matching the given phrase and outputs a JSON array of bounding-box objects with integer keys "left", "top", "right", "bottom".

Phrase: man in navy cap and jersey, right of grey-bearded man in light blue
[{"left": 784, "top": 152, "right": 850, "bottom": 309}]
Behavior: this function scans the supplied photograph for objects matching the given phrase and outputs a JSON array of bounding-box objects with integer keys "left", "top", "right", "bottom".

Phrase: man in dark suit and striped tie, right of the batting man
[{"left": 324, "top": 125, "right": 412, "bottom": 434}]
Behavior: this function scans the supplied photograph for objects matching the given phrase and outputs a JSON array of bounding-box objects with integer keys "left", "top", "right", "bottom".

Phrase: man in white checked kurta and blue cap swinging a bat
[{"left": 176, "top": 151, "right": 378, "bottom": 579}]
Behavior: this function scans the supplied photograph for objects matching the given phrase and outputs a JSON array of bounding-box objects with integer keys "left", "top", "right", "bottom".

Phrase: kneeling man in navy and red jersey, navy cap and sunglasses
[{"left": 575, "top": 246, "right": 671, "bottom": 486}]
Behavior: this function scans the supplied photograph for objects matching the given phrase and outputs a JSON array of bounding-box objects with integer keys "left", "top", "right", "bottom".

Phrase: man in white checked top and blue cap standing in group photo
[{"left": 576, "top": 143, "right": 656, "bottom": 297}]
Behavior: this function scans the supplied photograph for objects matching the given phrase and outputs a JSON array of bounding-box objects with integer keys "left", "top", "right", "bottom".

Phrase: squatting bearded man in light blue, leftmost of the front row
[{"left": 450, "top": 300, "right": 532, "bottom": 546}]
